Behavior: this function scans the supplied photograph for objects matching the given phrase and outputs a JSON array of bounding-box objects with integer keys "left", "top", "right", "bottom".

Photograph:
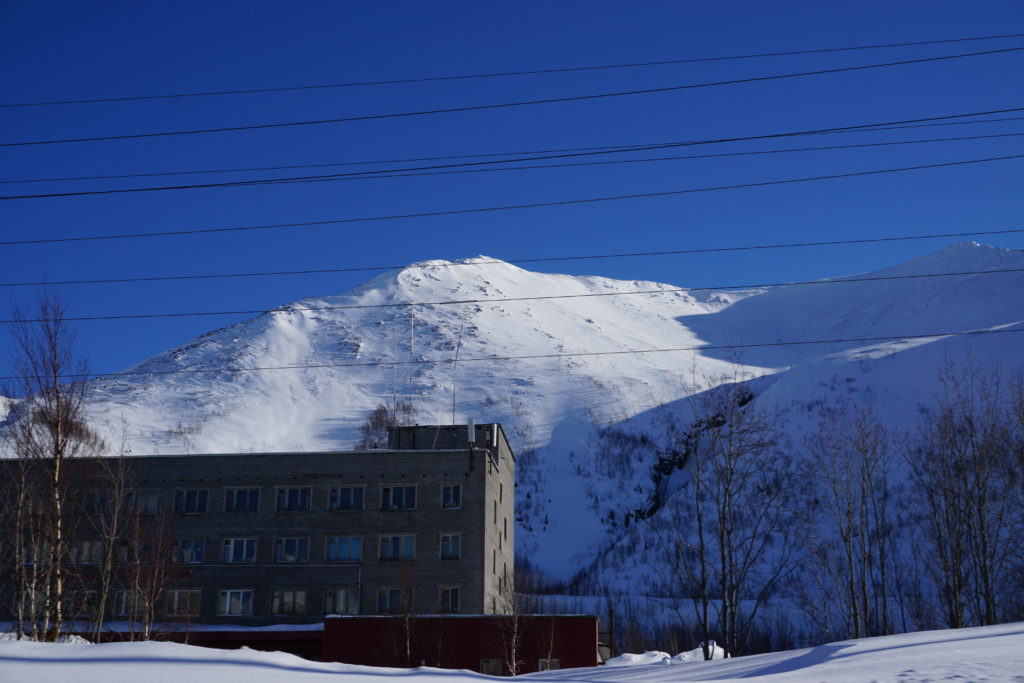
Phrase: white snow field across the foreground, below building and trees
[{"left": 0, "top": 624, "right": 1024, "bottom": 683}]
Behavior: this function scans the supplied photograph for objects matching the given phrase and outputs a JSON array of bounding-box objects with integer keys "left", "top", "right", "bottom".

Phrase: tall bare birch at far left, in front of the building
[{"left": 5, "top": 297, "right": 102, "bottom": 640}]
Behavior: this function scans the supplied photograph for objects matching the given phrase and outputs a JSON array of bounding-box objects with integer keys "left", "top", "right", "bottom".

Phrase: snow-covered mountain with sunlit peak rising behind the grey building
[{"left": 81, "top": 244, "right": 1024, "bottom": 574}]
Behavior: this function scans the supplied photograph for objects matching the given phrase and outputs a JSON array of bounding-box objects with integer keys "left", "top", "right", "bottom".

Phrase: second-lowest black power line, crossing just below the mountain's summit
[{"left": 0, "top": 268, "right": 1024, "bottom": 325}]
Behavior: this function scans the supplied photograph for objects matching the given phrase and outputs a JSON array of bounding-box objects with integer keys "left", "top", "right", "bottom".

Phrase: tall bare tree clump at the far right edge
[{"left": 907, "top": 362, "right": 1019, "bottom": 628}]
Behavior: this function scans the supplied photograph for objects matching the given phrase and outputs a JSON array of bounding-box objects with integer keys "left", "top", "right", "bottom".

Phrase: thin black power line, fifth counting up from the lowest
[{"left": 0, "top": 133, "right": 1024, "bottom": 201}]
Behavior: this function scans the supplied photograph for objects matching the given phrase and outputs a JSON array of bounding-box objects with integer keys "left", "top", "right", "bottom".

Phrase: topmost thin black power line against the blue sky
[{"left": 0, "top": 33, "right": 1024, "bottom": 109}]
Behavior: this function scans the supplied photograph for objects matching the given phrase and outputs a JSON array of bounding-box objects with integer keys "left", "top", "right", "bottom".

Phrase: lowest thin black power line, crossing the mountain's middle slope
[{"left": 6, "top": 328, "right": 1024, "bottom": 381}]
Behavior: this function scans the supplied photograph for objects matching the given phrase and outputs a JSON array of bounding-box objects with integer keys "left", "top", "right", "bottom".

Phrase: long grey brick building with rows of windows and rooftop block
[{"left": 2, "top": 424, "right": 515, "bottom": 626}]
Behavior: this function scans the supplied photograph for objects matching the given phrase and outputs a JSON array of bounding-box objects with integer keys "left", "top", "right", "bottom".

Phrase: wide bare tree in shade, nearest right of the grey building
[{"left": 642, "top": 373, "right": 804, "bottom": 658}]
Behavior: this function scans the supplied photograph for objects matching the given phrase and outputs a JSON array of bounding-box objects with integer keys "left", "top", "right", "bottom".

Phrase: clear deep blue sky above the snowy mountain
[{"left": 0, "top": 0, "right": 1024, "bottom": 375}]
